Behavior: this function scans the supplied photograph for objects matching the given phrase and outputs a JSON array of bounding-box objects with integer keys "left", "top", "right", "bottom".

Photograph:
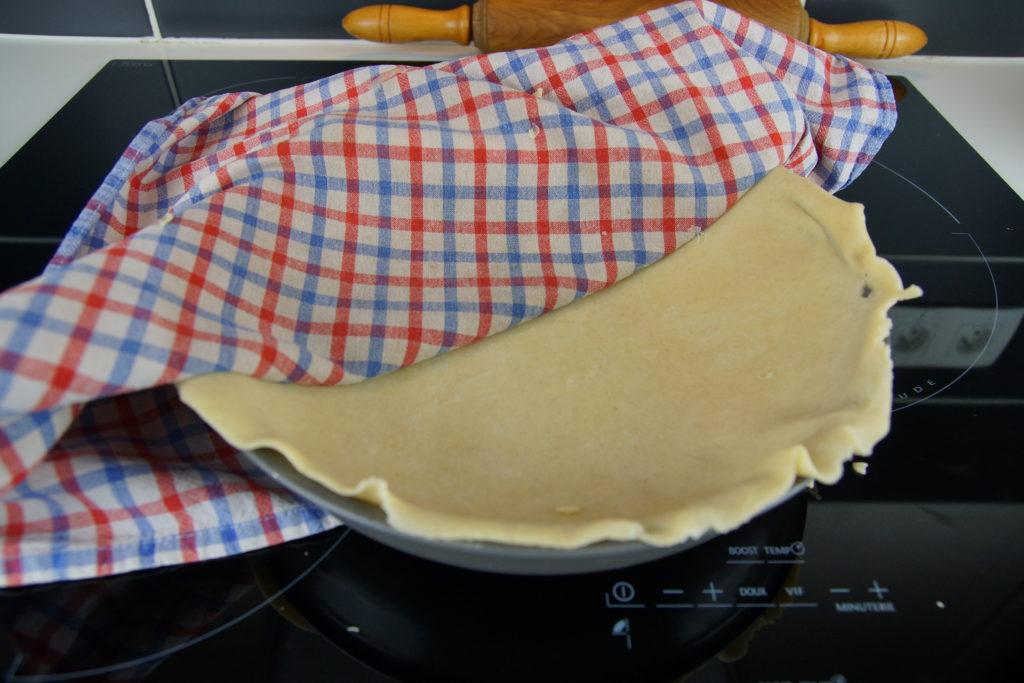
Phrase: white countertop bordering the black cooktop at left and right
[{"left": 0, "top": 34, "right": 1024, "bottom": 197}]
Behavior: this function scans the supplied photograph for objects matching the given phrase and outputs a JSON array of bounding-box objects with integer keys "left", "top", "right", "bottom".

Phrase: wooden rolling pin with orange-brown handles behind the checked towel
[{"left": 341, "top": 0, "right": 928, "bottom": 59}]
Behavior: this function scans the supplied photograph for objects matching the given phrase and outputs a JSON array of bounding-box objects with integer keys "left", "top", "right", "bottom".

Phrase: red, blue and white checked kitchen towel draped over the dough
[{"left": 0, "top": 1, "right": 895, "bottom": 585}]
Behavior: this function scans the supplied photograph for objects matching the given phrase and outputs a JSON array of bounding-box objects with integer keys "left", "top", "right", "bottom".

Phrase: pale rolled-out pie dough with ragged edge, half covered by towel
[{"left": 179, "top": 169, "right": 920, "bottom": 548}]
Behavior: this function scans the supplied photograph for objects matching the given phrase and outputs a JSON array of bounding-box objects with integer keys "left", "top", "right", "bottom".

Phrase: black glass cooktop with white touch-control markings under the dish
[{"left": 0, "top": 60, "right": 1024, "bottom": 683}]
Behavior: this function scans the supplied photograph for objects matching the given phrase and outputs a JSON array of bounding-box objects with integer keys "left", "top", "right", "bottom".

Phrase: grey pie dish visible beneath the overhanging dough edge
[{"left": 243, "top": 449, "right": 807, "bottom": 575}]
